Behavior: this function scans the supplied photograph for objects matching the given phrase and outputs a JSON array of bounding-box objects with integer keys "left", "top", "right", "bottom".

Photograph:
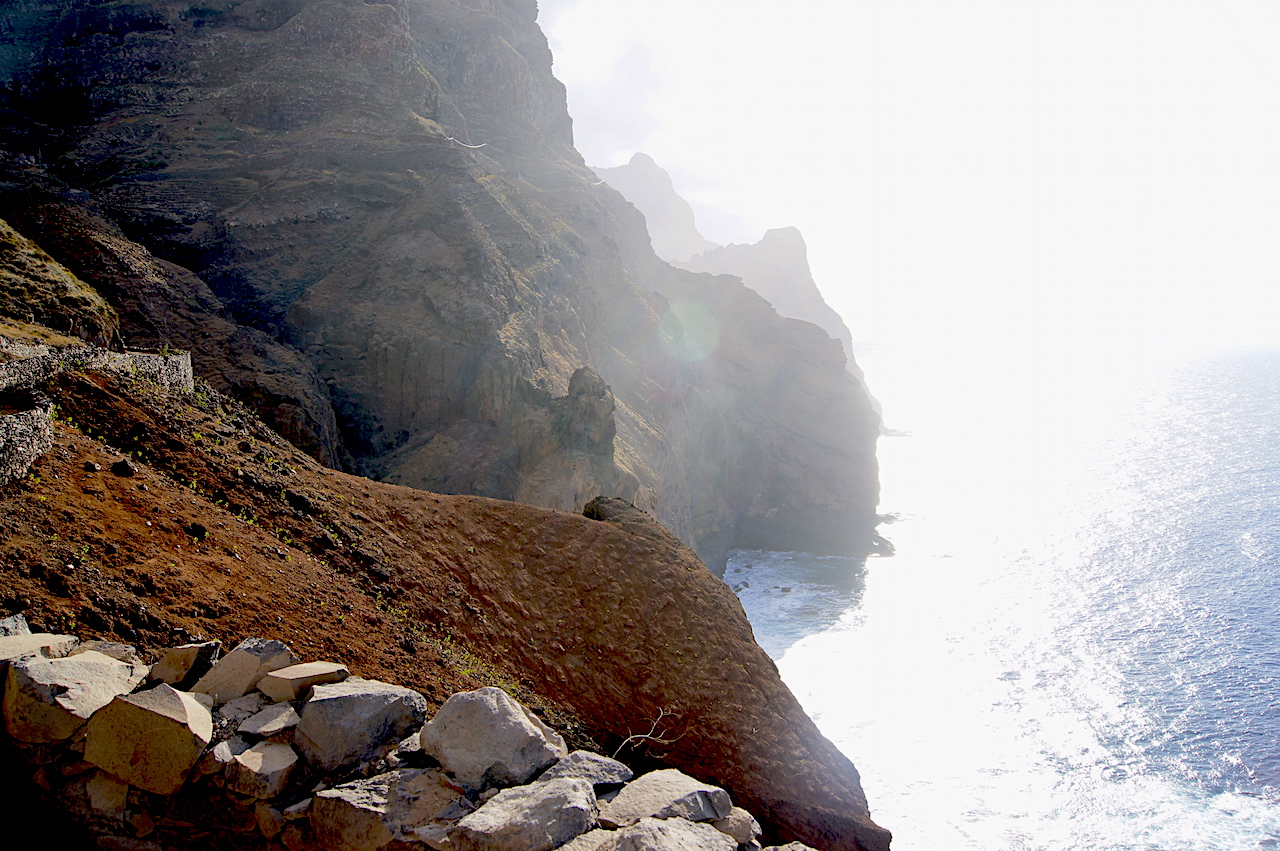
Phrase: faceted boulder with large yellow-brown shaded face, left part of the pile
[{"left": 84, "top": 685, "right": 214, "bottom": 795}]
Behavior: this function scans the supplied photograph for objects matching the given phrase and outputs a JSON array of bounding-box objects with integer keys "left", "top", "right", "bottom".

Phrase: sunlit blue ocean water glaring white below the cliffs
[{"left": 726, "top": 351, "right": 1280, "bottom": 851}]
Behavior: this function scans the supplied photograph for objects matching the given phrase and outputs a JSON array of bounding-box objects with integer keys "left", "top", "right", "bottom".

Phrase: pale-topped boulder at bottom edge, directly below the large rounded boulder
[{"left": 449, "top": 777, "right": 599, "bottom": 851}]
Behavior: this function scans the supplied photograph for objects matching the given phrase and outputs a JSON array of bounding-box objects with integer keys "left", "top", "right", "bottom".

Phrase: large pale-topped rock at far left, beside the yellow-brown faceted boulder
[{"left": 4, "top": 651, "right": 146, "bottom": 744}]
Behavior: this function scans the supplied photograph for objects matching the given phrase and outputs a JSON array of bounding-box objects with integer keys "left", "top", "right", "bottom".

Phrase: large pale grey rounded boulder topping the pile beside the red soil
[{"left": 422, "top": 686, "right": 568, "bottom": 791}]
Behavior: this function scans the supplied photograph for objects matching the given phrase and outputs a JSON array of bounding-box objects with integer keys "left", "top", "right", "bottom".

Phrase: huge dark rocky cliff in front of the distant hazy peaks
[{"left": 0, "top": 0, "right": 878, "bottom": 568}]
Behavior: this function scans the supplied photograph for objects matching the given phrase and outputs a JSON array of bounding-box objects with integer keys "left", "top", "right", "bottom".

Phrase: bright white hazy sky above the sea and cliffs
[{"left": 540, "top": 0, "right": 1280, "bottom": 352}]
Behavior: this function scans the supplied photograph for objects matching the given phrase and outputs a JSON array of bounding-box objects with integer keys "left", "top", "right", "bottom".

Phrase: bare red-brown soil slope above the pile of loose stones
[{"left": 0, "top": 374, "right": 888, "bottom": 850}]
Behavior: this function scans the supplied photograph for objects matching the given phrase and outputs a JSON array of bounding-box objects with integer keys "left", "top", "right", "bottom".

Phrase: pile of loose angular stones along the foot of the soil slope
[{"left": 0, "top": 616, "right": 805, "bottom": 851}]
